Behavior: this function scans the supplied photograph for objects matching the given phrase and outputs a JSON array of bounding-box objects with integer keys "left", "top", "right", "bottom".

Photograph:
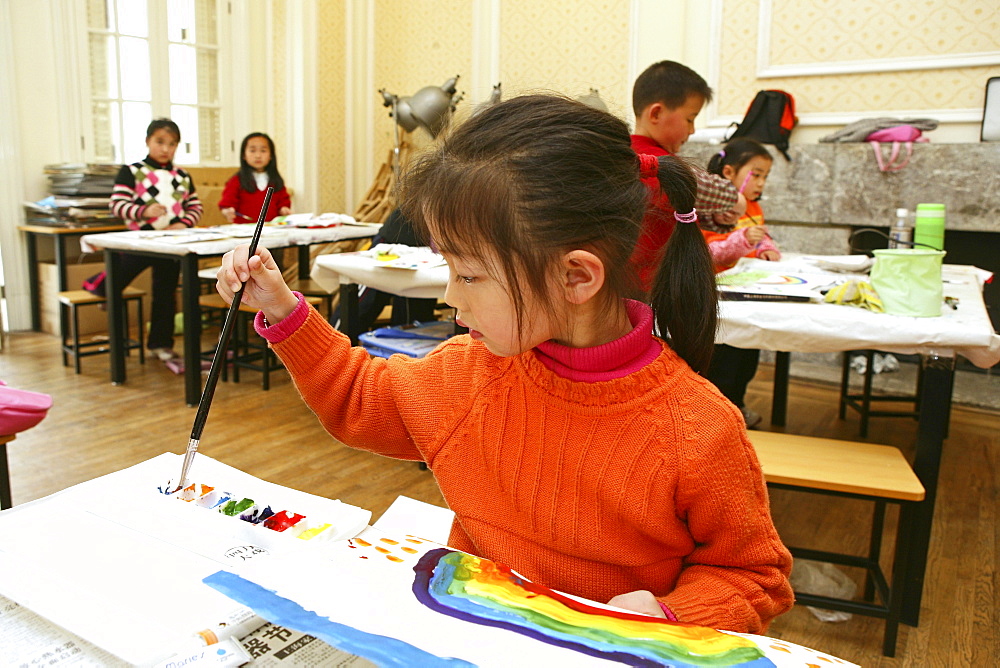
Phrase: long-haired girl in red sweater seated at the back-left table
[{"left": 219, "top": 132, "right": 292, "bottom": 223}]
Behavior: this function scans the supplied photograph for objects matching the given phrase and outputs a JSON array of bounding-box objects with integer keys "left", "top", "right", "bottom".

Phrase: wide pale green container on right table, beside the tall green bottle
[{"left": 871, "top": 248, "right": 945, "bottom": 318}]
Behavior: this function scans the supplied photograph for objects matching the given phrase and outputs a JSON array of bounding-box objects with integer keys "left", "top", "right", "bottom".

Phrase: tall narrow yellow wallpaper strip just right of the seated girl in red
[{"left": 316, "top": 0, "right": 347, "bottom": 211}]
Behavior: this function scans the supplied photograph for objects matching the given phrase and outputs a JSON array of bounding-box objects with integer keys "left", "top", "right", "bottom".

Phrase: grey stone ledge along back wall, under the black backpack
[{"left": 681, "top": 142, "right": 1000, "bottom": 232}]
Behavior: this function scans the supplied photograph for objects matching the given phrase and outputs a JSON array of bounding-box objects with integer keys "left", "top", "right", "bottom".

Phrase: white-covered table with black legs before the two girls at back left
[{"left": 81, "top": 224, "right": 380, "bottom": 406}]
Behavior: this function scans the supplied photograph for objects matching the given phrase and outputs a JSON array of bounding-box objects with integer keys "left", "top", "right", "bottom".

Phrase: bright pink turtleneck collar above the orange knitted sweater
[{"left": 535, "top": 299, "right": 662, "bottom": 383}]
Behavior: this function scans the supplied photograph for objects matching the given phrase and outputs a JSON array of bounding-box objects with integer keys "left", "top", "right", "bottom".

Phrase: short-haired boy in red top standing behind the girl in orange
[{"left": 631, "top": 60, "right": 747, "bottom": 291}]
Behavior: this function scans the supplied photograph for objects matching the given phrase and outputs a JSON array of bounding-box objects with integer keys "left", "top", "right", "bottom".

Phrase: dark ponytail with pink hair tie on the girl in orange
[{"left": 650, "top": 156, "right": 718, "bottom": 373}]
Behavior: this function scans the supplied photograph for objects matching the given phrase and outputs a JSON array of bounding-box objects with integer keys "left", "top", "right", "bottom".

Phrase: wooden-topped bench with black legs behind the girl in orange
[{"left": 749, "top": 431, "right": 924, "bottom": 656}]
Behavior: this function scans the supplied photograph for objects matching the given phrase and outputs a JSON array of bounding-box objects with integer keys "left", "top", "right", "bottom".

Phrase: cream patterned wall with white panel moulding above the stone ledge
[{"left": 711, "top": 0, "right": 1000, "bottom": 142}]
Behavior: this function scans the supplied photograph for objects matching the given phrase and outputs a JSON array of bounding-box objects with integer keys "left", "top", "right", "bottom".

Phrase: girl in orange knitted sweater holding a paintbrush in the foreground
[{"left": 218, "top": 95, "right": 793, "bottom": 633}]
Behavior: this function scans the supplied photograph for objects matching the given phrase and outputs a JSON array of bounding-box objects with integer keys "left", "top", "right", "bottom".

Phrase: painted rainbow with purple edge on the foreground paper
[{"left": 413, "top": 548, "right": 775, "bottom": 668}]
